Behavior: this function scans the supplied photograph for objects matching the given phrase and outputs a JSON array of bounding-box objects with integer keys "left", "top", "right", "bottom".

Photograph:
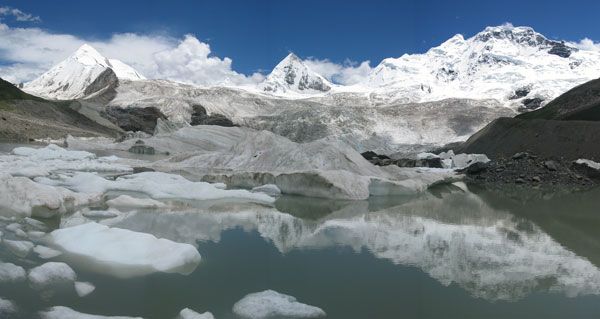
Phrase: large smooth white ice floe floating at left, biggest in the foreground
[{"left": 48, "top": 222, "right": 200, "bottom": 277}]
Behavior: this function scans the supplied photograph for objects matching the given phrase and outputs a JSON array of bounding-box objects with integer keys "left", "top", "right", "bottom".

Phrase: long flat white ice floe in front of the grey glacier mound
[{"left": 38, "top": 172, "right": 275, "bottom": 203}]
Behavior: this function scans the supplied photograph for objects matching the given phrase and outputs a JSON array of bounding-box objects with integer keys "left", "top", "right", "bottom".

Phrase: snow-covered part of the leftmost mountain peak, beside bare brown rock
[{"left": 23, "top": 44, "right": 145, "bottom": 100}]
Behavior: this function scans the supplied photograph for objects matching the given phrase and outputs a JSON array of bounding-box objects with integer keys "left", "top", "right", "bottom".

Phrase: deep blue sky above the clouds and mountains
[{"left": 0, "top": 0, "right": 600, "bottom": 85}]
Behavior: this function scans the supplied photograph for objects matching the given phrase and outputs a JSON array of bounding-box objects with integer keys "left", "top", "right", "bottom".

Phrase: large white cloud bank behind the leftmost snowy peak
[{"left": 0, "top": 23, "right": 263, "bottom": 85}]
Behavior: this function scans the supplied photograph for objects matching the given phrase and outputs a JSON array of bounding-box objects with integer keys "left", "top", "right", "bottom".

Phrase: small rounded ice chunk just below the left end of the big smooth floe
[{"left": 27, "top": 262, "right": 77, "bottom": 290}]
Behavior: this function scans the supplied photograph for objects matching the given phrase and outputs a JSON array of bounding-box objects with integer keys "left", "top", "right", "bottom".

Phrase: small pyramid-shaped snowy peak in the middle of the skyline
[{"left": 259, "top": 53, "right": 333, "bottom": 95}]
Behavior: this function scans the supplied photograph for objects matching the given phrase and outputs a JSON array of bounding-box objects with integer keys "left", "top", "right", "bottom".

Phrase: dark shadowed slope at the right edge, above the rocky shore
[{"left": 458, "top": 79, "right": 600, "bottom": 161}]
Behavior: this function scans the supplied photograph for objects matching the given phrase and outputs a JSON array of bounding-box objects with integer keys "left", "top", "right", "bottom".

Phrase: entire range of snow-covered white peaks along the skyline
[{"left": 19, "top": 25, "right": 600, "bottom": 109}]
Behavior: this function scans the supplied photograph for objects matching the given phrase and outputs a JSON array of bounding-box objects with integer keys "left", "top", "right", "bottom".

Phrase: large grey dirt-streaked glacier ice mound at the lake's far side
[{"left": 67, "top": 126, "right": 458, "bottom": 199}]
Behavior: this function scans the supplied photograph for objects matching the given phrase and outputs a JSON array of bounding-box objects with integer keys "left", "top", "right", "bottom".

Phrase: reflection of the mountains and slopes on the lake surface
[{"left": 97, "top": 187, "right": 600, "bottom": 300}]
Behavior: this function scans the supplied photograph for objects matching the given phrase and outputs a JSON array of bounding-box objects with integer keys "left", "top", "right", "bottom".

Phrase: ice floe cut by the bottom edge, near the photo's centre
[{"left": 233, "top": 290, "right": 326, "bottom": 319}]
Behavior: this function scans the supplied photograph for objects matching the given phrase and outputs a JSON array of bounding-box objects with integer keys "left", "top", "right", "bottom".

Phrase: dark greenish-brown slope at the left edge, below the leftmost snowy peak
[{"left": 0, "top": 79, "right": 120, "bottom": 141}]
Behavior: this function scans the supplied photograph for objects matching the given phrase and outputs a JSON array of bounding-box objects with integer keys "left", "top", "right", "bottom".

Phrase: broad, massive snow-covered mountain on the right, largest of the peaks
[{"left": 359, "top": 25, "right": 600, "bottom": 108}]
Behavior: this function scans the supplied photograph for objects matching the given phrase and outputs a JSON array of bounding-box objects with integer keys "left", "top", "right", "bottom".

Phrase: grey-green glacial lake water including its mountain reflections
[{"left": 0, "top": 181, "right": 600, "bottom": 319}]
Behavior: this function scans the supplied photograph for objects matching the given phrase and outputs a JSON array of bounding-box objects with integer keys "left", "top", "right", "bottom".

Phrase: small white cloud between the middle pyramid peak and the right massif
[{"left": 304, "top": 58, "right": 372, "bottom": 85}]
